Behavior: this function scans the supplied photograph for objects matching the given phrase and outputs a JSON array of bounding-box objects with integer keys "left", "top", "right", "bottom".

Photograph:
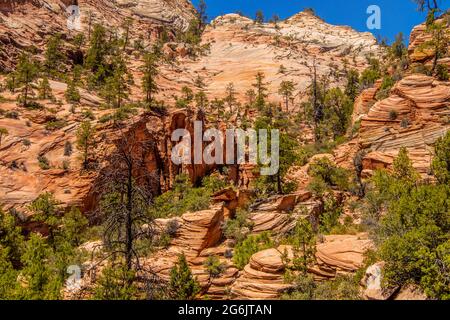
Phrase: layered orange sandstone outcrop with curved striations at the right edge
[{"left": 360, "top": 75, "right": 450, "bottom": 176}]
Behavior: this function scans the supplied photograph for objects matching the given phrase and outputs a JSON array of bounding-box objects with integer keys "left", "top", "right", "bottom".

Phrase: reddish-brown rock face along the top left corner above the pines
[{"left": 0, "top": 0, "right": 195, "bottom": 70}]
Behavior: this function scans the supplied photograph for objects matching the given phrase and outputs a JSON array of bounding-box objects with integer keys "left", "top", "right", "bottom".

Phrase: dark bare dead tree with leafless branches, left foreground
[{"left": 98, "top": 124, "right": 159, "bottom": 271}]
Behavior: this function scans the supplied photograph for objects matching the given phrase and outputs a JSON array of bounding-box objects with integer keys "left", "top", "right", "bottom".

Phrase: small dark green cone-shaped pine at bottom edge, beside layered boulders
[{"left": 168, "top": 254, "right": 200, "bottom": 300}]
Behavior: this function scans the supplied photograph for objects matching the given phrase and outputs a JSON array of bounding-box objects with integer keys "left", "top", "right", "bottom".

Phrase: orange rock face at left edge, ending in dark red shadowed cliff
[{"left": 0, "top": 81, "right": 211, "bottom": 216}]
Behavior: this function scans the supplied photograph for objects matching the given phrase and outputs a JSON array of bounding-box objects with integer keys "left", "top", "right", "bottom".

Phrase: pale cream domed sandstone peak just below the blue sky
[{"left": 168, "top": 12, "right": 381, "bottom": 102}]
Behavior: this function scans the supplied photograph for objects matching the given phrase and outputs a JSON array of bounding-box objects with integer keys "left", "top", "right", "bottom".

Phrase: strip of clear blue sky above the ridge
[{"left": 192, "top": 0, "right": 450, "bottom": 41}]
